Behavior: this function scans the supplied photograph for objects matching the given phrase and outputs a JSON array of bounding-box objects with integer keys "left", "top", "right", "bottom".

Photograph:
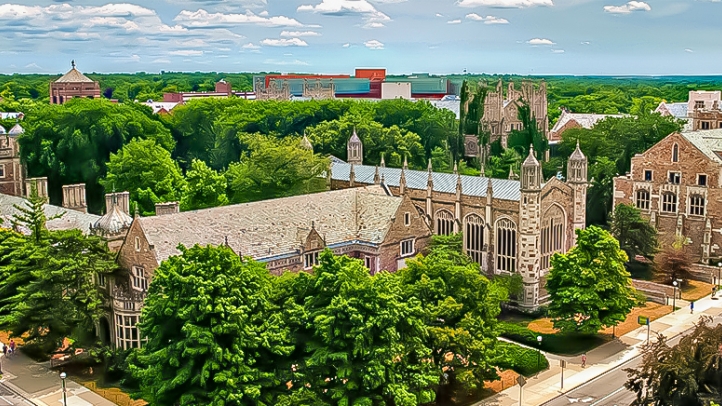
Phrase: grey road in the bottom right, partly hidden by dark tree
[{"left": 542, "top": 316, "right": 722, "bottom": 406}]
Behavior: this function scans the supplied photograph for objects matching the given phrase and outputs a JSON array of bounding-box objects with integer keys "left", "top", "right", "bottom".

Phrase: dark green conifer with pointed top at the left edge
[{"left": 0, "top": 188, "right": 115, "bottom": 353}]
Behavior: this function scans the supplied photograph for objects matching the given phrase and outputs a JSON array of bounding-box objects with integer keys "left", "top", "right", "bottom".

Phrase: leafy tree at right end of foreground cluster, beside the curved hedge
[{"left": 397, "top": 234, "right": 507, "bottom": 403}]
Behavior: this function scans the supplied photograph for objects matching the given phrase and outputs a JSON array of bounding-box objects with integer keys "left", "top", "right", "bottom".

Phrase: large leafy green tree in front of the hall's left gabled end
[{"left": 130, "top": 246, "right": 292, "bottom": 406}]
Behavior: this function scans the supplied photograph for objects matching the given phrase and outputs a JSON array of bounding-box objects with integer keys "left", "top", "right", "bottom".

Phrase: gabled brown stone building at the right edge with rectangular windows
[{"left": 614, "top": 129, "right": 722, "bottom": 264}]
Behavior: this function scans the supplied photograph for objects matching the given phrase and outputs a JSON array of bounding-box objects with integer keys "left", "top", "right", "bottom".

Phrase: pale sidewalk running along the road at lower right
[{"left": 475, "top": 296, "right": 722, "bottom": 406}]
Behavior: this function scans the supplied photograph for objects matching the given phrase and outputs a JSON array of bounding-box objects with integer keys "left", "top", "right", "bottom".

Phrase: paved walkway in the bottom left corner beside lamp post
[{"left": 0, "top": 351, "right": 115, "bottom": 406}]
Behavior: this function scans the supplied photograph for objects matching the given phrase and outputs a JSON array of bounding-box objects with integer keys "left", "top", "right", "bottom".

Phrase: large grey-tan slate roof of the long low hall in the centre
[{"left": 135, "top": 186, "right": 402, "bottom": 263}]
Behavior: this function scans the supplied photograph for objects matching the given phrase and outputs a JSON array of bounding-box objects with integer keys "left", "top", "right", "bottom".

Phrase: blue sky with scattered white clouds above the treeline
[{"left": 0, "top": 0, "right": 722, "bottom": 75}]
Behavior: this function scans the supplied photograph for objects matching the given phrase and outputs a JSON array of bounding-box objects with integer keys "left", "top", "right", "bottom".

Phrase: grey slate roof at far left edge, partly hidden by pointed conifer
[{"left": 0, "top": 193, "right": 100, "bottom": 234}]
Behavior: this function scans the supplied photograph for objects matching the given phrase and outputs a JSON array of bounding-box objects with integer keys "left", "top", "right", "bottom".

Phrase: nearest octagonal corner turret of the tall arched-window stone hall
[{"left": 517, "top": 146, "right": 542, "bottom": 309}]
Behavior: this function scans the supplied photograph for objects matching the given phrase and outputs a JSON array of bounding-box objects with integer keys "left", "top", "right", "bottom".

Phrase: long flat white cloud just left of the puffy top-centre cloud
[{"left": 173, "top": 9, "right": 303, "bottom": 27}]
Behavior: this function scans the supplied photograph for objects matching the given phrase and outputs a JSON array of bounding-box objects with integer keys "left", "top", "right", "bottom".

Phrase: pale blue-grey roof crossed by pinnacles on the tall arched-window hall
[{"left": 331, "top": 162, "right": 521, "bottom": 201}]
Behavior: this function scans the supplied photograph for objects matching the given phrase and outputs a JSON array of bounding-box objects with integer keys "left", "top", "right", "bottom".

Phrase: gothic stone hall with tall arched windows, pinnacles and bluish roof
[{"left": 328, "top": 137, "right": 587, "bottom": 309}]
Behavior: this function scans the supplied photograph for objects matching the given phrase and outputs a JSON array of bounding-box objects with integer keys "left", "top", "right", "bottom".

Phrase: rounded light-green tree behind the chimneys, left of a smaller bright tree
[{"left": 100, "top": 139, "right": 186, "bottom": 216}]
